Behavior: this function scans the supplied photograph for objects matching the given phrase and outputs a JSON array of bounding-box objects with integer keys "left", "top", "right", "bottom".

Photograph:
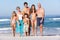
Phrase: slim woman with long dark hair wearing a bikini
[{"left": 30, "top": 4, "right": 36, "bottom": 35}]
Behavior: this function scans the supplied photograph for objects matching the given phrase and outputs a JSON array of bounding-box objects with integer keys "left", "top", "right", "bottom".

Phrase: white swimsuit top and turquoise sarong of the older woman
[{"left": 16, "top": 14, "right": 24, "bottom": 35}]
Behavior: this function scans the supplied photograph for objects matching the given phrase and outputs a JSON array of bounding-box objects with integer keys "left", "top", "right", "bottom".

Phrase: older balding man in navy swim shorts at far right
[{"left": 37, "top": 3, "right": 45, "bottom": 35}]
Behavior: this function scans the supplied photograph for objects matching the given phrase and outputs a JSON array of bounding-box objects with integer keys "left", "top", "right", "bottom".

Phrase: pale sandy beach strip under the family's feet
[{"left": 0, "top": 33, "right": 60, "bottom": 40}]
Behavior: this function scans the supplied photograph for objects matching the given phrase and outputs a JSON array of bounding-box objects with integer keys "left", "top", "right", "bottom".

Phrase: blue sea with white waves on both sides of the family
[{"left": 0, "top": 17, "right": 60, "bottom": 35}]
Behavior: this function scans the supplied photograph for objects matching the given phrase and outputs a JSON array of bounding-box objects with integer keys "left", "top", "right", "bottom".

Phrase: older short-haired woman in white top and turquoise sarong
[{"left": 16, "top": 7, "right": 24, "bottom": 35}]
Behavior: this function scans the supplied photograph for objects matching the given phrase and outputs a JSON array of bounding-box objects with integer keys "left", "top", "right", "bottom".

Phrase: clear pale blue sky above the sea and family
[{"left": 0, "top": 0, "right": 60, "bottom": 17}]
